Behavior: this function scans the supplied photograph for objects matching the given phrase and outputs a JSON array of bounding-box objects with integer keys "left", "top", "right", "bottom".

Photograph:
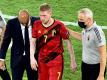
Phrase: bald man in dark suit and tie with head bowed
[{"left": 0, "top": 10, "right": 39, "bottom": 80}]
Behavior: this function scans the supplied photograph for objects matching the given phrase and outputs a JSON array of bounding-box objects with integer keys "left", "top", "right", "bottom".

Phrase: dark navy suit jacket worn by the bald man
[{"left": 0, "top": 17, "right": 39, "bottom": 68}]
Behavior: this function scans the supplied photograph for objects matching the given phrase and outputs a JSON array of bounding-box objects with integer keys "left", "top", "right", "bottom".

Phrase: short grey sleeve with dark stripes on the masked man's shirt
[{"left": 94, "top": 28, "right": 106, "bottom": 47}]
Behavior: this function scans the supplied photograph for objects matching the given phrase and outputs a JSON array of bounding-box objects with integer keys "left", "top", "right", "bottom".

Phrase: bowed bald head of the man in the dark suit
[{"left": 18, "top": 12, "right": 29, "bottom": 25}]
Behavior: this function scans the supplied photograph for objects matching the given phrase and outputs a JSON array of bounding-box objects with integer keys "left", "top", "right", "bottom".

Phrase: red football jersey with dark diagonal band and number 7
[{"left": 32, "top": 20, "right": 69, "bottom": 56}]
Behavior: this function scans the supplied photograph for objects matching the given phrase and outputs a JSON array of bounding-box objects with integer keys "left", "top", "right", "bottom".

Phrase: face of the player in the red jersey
[{"left": 39, "top": 10, "right": 51, "bottom": 24}]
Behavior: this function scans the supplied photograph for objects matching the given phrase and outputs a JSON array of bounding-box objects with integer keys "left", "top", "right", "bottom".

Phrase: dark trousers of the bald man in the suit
[{"left": 12, "top": 56, "right": 38, "bottom": 80}]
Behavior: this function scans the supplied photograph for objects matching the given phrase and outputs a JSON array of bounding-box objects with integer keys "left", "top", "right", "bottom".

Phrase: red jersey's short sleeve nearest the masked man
[{"left": 60, "top": 23, "right": 69, "bottom": 39}]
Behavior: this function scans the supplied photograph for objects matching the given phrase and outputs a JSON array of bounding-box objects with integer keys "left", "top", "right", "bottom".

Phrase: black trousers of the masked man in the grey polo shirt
[{"left": 81, "top": 62, "right": 106, "bottom": 80}]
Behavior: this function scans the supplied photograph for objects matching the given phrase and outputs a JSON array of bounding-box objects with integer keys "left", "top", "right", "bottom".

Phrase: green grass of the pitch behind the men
[{"left": 0, "top": 0, "right": 107, "bottom": 80}]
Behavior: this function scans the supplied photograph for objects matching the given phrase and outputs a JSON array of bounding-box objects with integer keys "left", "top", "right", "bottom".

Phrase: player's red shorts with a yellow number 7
[{"left": 38, "top": 54, "right": 64, "bottom": 80}]
